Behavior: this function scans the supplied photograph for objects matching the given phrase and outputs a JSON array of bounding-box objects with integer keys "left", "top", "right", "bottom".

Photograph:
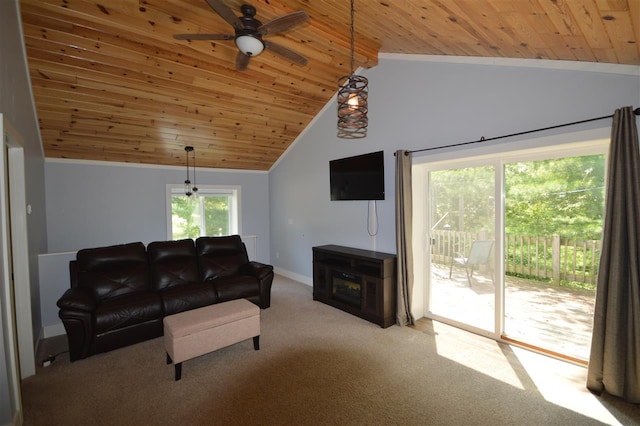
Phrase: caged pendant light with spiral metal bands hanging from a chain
[{"left": 338, "top": 0, "right": 369, "bottom": 139}]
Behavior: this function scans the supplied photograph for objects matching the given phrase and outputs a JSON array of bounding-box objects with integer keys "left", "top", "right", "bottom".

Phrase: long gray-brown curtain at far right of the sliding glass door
[{"left": 587, "top": 107, "right": 640, "bottom": 404}]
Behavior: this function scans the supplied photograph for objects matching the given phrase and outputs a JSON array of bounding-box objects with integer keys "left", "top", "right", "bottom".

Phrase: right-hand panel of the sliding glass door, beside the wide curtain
[{"left": 504, "top": 155, "right": 605, "bottom": 360}]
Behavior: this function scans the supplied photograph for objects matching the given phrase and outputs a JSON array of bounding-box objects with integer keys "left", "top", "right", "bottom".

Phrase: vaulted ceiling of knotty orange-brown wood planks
[{"left": 19, "top": 0, "right": 640, "bottom": 170}]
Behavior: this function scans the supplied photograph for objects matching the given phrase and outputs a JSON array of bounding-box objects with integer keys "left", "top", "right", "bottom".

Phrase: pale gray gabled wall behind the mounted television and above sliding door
[{"left": 269, "top": 55, "right": 640, "bottom": 283}]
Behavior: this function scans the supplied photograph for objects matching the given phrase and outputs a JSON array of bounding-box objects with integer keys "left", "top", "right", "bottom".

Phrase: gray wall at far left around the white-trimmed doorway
[{"left": 0, "top": 0, "right": 47, "bottom": 424}]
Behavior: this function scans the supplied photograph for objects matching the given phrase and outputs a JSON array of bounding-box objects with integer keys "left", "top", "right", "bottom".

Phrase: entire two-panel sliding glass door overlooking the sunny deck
[{"left": 419, "top": 143, "right": 606, "bottom": 360}]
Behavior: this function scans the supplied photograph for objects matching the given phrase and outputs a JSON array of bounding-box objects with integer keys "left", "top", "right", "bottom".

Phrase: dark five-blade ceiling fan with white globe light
[{"left": 173, "top": 0, "right": 309, "bottom": 71}]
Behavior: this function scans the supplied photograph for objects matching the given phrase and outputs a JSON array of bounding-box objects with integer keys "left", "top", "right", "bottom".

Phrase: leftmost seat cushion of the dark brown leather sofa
[{"left": 95, "top": 292, "right": 162, "bottom": 334}]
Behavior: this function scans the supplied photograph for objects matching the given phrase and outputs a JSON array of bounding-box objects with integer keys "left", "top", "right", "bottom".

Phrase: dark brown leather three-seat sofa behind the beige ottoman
[{"left": 57, "top": 235, "right": 273, "bottom": 361}]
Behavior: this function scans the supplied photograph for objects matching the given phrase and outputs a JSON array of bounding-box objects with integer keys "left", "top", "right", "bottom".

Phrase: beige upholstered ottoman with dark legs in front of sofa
[{"left": 164, "top": 299, "right": 260, "bottom": 380}]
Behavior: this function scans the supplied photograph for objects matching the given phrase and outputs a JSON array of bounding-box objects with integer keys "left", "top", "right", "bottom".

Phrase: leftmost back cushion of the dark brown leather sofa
[{"left": 76, "top": 242, "right": 151, "bottom": 299}]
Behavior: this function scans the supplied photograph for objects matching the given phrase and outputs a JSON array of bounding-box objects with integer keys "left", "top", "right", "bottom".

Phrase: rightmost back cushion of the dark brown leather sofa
[{"left": 196, "top": 235, "right": 249, "bottom": 280}]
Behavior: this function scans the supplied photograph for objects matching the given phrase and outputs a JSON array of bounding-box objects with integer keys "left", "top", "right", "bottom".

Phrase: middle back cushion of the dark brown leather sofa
[{"left": 147, "top": 239, "right": 198, "bottom": 290}]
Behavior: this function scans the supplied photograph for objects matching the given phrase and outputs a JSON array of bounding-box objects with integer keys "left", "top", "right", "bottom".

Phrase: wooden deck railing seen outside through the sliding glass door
[{"left": 431, "top": 230, "right": 600, "bottom": 284}]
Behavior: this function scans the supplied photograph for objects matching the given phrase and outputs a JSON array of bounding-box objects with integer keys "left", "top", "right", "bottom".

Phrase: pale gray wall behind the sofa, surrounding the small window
[{"left": 45, "top": 161, "right": 270, "bottom": 263}]
